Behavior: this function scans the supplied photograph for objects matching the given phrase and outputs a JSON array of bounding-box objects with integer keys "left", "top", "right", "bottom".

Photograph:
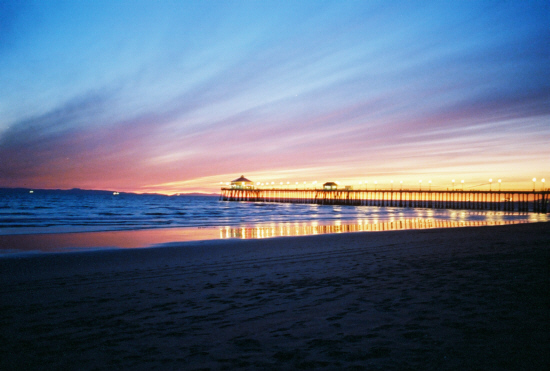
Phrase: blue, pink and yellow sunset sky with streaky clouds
[{"left": 0, "top": 0, "right": 550, "bottom": 193}]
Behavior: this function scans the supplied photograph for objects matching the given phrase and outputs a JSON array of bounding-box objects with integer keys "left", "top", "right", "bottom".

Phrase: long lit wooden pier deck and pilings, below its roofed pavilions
[{"left": 220, "top": 188, "right": 550, "bottom": 213}]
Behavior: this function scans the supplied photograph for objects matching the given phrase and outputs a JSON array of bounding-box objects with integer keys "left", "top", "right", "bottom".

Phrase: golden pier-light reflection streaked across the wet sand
[{"left": 220, "top": 218, "right": 526, "bottom": 239}]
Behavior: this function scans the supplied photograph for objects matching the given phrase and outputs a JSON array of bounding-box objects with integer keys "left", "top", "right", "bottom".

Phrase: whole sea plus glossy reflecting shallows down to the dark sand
[{"left": 0, "top": 191, "right": 548, "bottom": 252}]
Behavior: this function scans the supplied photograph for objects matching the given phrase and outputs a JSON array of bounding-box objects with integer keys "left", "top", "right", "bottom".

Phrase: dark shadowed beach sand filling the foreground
[{"left": 0, "top": 223, "right": 550, "bottom": 370}]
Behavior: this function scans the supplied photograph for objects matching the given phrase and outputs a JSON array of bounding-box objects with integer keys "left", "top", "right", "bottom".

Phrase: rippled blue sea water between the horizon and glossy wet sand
[{"left": 0, "top": 194, "right": 548, "bottom": 234}]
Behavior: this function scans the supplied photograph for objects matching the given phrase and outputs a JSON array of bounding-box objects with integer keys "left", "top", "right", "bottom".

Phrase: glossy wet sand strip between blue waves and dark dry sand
[{"left": 0, "top": 218, "right": 546, "bottom": 259}]
